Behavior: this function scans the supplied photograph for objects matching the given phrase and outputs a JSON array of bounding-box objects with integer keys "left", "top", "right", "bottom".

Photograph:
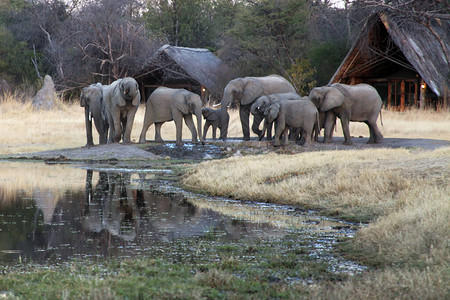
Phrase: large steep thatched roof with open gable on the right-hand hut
[{"left": 330, "top": 13, "right": 450, "bottom": 97}]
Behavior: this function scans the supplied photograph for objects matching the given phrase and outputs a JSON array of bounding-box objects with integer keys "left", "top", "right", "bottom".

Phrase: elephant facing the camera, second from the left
[{"left": 103, "top": 77, "right": 141, "bottom": 144}]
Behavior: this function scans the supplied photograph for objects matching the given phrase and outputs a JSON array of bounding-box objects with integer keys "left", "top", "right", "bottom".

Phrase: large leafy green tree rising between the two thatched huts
[{"left": 228, "top": 0, "right": 310, "bottom": 76}]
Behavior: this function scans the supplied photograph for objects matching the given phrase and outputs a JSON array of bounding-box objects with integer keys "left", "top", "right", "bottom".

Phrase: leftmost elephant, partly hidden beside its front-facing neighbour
[{"left": 80, "top": 83, "right": 109, "bottom": 147}]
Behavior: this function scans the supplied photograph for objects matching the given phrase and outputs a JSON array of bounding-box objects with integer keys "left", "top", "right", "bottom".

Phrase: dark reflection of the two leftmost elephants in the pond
[{"left": 82, "top": 170, "right": 140, "bottom": 241}]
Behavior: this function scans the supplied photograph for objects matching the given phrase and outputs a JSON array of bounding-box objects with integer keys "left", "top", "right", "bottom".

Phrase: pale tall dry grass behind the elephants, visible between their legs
[{"left": 0, "top": 92, "right": 450, "bottom": 154}]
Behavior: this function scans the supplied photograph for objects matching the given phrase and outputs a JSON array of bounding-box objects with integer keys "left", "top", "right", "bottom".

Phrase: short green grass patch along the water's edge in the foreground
[{"left": 0, "top": 232, "right": 346, "bottom": 299}]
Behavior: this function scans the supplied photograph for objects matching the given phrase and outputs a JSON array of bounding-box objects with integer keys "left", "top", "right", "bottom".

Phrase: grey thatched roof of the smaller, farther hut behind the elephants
[{"left": 136, "top": 45, "right": 230, "bottom": 90}]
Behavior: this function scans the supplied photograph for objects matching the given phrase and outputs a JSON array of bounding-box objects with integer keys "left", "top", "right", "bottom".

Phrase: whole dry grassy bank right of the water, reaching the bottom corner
[{"left": 184, "top": 147, "right": 450, "bottom": 299}]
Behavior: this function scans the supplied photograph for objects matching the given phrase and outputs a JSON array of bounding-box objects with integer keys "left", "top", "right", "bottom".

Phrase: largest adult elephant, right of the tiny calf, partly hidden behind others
[{"left": 220, "top": 75, "right": 295, "bottom": 140}]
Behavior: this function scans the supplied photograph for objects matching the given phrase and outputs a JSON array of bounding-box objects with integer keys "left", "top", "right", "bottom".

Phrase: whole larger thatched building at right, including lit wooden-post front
[{"left": 330, "top": 13, "right": 450, "bottom": 111}]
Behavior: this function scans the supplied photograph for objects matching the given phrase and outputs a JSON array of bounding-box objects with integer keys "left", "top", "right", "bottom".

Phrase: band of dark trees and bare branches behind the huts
[{"left": 0, "top": 0, "right": 450, "bottom": 93}]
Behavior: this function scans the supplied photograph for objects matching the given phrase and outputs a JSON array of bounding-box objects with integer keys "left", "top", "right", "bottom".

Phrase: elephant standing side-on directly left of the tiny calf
[{"left": 139, "top": 87, "right": 205, "bottom": 146}]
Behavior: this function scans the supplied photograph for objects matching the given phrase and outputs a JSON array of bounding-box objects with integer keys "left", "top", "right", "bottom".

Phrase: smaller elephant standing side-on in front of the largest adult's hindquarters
[{"left": 265, "top": 100, "right": 319, "bottom": 147}]
